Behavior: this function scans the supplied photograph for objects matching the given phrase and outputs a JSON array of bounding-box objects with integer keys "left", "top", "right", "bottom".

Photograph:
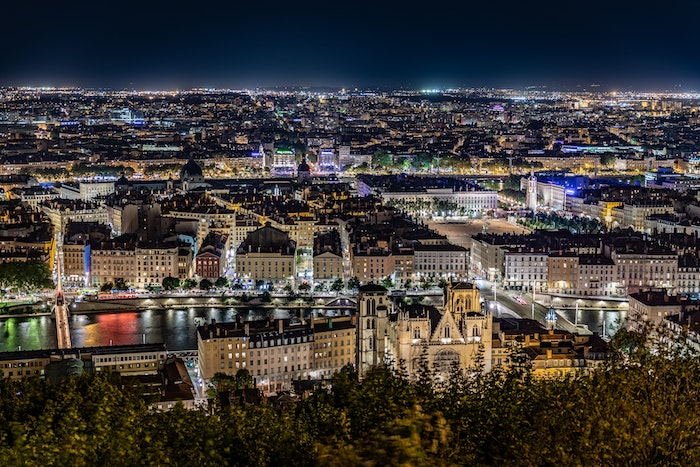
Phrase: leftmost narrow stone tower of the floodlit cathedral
[{"left": 356, "top": 284, "right": 391, "bottom": 378}]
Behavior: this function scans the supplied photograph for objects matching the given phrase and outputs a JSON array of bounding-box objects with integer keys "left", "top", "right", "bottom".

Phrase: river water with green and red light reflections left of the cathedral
[{"left": 0, "top": 308, "right": 350, "bottom": 352}]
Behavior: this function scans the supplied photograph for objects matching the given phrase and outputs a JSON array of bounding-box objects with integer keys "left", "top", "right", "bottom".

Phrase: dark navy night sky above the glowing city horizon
[{"left": 0, "top": 0, "right": 700, "bottom": 91}]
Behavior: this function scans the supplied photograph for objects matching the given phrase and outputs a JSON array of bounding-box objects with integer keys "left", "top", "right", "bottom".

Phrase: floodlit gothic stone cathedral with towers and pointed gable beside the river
[{"left": 356, "top": 282, "right": 493, "bottom": 380}]
